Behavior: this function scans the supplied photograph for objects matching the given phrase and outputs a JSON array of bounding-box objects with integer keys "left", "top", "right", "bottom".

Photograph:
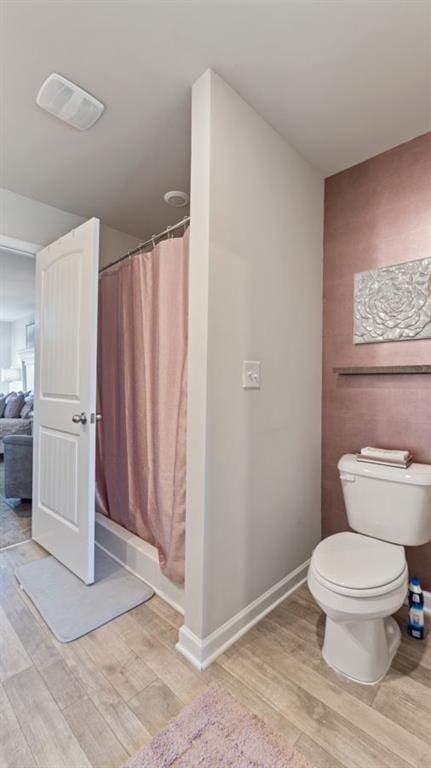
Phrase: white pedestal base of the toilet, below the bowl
[{"left": 322, "top": 616, "right": 401, "bottom": 685}]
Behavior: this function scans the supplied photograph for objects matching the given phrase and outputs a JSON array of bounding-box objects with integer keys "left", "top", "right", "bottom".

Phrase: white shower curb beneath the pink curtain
[{"left": 96, "top": 512, "right": 184, "bottom": 614}]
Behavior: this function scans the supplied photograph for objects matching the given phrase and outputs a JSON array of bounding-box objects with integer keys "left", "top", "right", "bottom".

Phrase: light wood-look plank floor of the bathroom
[{"left": 0, "top": 542, "right": 431, "bottom": 768}]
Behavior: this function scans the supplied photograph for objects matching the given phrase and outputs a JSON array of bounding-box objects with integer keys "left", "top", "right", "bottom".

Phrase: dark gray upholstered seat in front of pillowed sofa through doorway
[{"left": 4, "top": 435, "right": 33, "bottom": 499}]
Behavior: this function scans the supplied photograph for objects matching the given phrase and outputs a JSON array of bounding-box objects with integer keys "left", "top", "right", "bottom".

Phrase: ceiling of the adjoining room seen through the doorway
[{"left": 0, "top": 248, "right": 35, "bottom": 323}]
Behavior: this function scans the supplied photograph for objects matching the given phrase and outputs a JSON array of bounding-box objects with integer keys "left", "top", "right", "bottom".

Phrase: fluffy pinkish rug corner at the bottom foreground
[{"left": 123, "top": 685, "right": 311, "bottom": 768}]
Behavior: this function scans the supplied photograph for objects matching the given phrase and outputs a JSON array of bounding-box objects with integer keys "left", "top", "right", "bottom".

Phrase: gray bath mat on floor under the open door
[{"left": 15, "top": 547, "right": 154, "bottom": 643}]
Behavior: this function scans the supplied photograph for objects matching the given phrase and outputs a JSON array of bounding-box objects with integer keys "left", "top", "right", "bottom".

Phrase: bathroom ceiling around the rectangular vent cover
[{"left": 0, "top": 0, "right": 431, "bottom": 237}]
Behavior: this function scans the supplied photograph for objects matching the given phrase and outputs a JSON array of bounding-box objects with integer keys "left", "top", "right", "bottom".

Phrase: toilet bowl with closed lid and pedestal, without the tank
[{"left": 308, "top": 533, "right": 408, "bottom": 685}]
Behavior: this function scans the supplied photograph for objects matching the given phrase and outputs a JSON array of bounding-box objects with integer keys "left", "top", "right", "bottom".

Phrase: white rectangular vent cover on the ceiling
[{"left": 36, "top": 72, "right": 105, "bottom": 131}]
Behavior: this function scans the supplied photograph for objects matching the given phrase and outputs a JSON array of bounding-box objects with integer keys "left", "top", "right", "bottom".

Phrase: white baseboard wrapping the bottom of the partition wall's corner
[{"left": 176, "top": 560, "right": 310, "bottom": 670}]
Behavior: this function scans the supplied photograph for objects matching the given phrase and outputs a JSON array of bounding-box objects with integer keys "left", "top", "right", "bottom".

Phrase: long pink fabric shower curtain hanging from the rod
[{"left": 96, "top": 232, "right": 189, "bottom": 583}]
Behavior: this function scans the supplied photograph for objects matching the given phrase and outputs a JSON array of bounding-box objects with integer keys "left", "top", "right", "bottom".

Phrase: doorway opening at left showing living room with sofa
[{"left": 0, "top": 235, "right": 38, "bottom": 549}]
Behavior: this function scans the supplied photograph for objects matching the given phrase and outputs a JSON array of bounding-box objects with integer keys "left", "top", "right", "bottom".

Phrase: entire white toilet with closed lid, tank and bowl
[{"left": 308, "top": 454, "right": 431, "bottom": 684}]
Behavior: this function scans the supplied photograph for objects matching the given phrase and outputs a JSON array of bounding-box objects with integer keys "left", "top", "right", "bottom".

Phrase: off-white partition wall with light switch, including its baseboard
[{"left": 178, "top": 72, "right": 323, "bottom": 665}]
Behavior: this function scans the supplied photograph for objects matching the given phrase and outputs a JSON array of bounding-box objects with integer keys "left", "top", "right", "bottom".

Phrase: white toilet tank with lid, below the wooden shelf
[{"left": 338, "top": 454, "right": 431, "bottom": 547}]
